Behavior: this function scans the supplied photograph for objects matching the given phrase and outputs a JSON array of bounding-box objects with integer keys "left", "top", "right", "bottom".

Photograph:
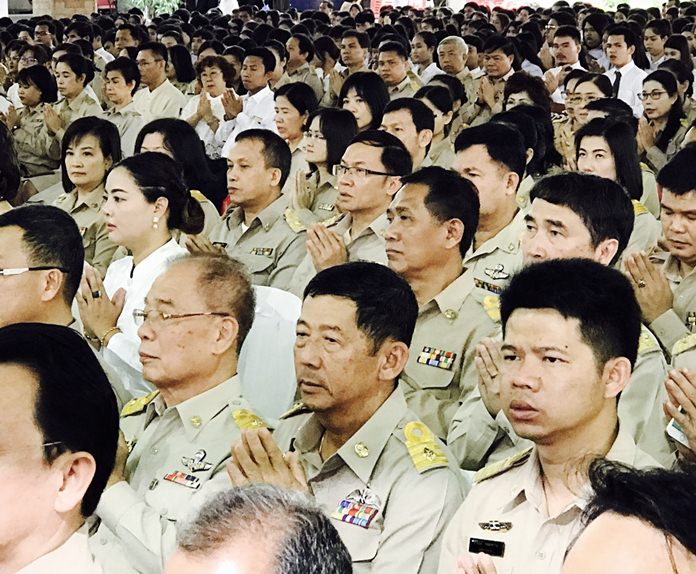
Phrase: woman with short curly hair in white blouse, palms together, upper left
[{"left": 181, "top": 56, "right": 235, "bottom": 159}]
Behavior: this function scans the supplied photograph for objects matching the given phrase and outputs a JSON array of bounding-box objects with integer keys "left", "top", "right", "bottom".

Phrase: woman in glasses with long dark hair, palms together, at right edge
[{"left": 638, "top": 70, "right": 688, "bottom": 173}]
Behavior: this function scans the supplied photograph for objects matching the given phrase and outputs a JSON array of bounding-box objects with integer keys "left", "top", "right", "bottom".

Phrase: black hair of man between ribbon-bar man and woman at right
[{"left": 454, "top": 123, "right": 527, "bottom": 180}]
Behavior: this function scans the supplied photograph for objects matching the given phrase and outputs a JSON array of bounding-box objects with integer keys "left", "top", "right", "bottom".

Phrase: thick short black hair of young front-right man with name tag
[{"left": 500, "top": 259, "right": 641, "bottom": 371}]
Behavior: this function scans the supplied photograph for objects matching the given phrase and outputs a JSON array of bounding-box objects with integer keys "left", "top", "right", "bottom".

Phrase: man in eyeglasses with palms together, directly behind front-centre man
[{"left": 290, "top": 130, "right": 412, "bottom": 297}]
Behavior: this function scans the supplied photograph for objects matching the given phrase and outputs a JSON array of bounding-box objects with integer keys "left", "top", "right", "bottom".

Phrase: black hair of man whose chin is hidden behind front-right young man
[{"left": 529, "top": 172, "right": 635, "bottom": 264}]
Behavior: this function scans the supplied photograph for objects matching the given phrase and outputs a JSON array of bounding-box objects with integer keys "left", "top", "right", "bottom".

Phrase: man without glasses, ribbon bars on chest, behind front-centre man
[{"left": 385, "top": 167, "right": 498, "bottom": 440}]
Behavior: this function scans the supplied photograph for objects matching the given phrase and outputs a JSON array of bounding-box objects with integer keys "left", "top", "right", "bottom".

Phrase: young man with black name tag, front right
[{"left": 438, "top": 259, "right": 659, "bottom": 574}]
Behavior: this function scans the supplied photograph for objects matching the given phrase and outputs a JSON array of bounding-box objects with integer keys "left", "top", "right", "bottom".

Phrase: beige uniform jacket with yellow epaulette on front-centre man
[{"left": 276, "top": 388, "right": 464, "bottom": 574}]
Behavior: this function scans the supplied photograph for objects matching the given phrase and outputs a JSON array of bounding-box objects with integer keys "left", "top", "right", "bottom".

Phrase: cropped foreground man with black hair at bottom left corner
[{"left": 0, "top": 326, "right": 118, "bottom": 574}]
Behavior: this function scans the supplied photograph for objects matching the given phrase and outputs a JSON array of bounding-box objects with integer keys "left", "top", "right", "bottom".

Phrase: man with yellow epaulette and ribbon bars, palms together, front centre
[{"left": 229, "top": 262, "right": 462, "bottom": 574}]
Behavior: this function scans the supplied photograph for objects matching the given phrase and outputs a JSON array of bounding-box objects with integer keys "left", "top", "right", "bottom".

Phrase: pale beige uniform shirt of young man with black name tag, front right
[{"left": 437, "top": 431, "right": 659, "bottom": 574}]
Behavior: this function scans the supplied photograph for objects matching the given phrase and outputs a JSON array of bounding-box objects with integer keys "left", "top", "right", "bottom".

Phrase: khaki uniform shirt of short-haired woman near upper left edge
[{"left": 12, "top": 104, "right": 60, "bottom": 177}]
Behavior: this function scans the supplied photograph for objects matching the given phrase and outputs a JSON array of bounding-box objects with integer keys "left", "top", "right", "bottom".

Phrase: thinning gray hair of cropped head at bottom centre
[{"left": 177, "top": 484, "right": 353, "bottom": 574}]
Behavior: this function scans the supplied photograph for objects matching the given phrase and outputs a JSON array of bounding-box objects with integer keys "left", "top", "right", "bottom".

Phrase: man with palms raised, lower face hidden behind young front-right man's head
[{"left": 447, "top": 173, "right": 674, "bottom": 470}]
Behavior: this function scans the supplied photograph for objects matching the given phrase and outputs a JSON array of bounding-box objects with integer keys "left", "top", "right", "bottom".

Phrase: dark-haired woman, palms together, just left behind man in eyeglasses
[{"left": 287, "top": 108, "right": 358, "bottom": 227}]
